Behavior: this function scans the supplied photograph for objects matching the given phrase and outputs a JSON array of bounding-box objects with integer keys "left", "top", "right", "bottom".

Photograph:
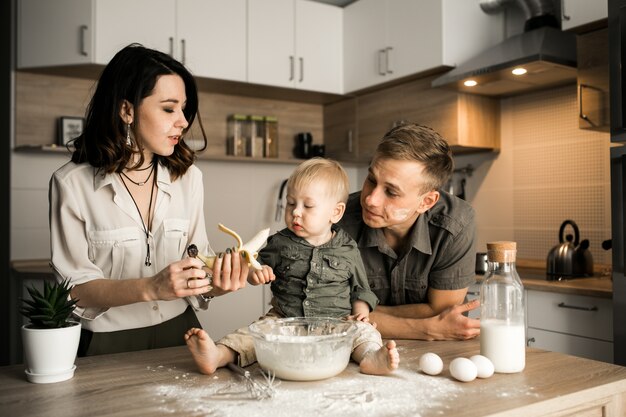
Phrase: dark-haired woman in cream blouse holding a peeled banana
[{"left": 49, "top": 44, "right": 248, "bottom": 356}]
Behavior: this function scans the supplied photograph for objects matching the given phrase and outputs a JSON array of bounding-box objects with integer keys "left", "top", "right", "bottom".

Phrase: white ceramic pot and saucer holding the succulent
[{"left": 22, "top": 322, "right": 81, "bottom": 383}]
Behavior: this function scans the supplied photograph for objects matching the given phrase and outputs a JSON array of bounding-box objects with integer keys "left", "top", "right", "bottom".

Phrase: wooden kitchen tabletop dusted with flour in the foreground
[{"left": 0, "top": 340, "right": 626, "bottom": 417}]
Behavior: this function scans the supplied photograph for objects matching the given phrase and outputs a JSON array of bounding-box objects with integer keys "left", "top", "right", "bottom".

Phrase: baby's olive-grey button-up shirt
[{"left": 259, "top": 228, "right": 378, "bottom": 317}]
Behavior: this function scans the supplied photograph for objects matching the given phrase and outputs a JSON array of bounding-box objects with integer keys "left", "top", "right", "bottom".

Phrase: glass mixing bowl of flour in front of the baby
[{"left": 249, "top": 317, "right": 356, "bottom": 381}]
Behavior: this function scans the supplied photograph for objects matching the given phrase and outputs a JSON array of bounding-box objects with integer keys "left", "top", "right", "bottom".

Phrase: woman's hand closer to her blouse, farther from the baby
[{"left": 150, "top": 258, "right": 211, "bottom": 301}]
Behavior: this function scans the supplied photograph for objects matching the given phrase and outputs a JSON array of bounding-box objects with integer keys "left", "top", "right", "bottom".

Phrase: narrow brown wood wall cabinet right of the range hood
[{"left": 576, "top": 28, "right": 611, "bottom": 132}]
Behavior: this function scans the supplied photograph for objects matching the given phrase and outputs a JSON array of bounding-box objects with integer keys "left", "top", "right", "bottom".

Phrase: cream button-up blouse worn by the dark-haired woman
[{"left": 48, "top": 162, "right": 213, "bottom": 332}]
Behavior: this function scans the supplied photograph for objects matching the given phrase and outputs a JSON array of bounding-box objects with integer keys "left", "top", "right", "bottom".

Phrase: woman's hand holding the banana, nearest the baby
[{"left": 205, "top": 249, "right": 249, "bottom": 296}]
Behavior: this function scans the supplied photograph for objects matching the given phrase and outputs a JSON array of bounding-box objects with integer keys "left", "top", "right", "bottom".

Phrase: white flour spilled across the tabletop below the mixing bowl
[{"left": 147, "top": 362, "right": 462, "bottom": 417}]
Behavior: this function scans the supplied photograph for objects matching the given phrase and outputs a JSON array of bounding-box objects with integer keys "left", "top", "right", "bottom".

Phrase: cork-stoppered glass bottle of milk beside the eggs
[{"left": 480, "top": 242, "right": 526, "bottom": 373}]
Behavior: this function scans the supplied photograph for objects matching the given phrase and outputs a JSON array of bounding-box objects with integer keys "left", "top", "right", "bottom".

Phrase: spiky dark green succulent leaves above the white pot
[{"left": 20, "top": 280, "right": 78, "bottom": 329}]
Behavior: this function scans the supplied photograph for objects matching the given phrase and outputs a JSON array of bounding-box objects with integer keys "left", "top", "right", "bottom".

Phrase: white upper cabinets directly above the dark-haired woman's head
[{"left": 18, "top": 0, "right": 246, "bottom": 81}]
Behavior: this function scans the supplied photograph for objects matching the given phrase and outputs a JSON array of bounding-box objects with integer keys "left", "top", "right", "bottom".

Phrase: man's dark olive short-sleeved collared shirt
[{"left": 338, "top": 191, "right": 476, "bottom": 306}]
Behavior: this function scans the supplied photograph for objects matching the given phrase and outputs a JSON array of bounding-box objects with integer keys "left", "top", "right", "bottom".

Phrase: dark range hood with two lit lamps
[{"left": 432, "top": 0, "right": 576, "bottom": 96}]
